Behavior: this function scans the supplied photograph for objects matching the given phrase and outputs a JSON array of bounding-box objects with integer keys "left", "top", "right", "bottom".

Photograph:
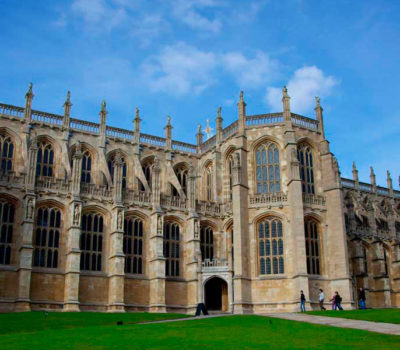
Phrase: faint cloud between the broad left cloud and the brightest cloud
[{"left": 222, "top": 51, "right": 279, "bottom": 89}]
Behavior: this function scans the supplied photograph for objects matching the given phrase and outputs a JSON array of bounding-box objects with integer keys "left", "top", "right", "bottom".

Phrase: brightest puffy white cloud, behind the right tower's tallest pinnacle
[{"left": 265, "top": 66, "right": 339, "bottom": 113}]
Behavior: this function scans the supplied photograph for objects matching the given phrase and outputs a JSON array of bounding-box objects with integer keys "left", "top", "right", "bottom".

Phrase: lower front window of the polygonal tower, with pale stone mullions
[{"left": 258, "top": 218, "right": 285, "bottom": 275}]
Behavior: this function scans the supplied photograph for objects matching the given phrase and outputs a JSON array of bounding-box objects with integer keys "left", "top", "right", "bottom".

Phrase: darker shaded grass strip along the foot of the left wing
[{"left": 0, "top": 311, "right": 188, "bottom": 335}]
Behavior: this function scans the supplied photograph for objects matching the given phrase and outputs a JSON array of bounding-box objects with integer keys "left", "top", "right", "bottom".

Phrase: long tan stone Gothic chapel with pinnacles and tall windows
[{"left": 0, "top": 85, "right": 400, "bottom": 313}]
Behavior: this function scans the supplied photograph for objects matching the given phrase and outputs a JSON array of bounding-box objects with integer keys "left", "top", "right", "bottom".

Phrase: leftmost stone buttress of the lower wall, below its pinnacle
[{"left": 15, "top": 192, "right": 36, "bottom": 311}]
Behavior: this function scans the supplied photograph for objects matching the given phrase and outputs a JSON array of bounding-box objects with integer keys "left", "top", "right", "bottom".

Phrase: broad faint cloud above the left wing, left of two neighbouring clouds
[{"left": 141, "top": 43, "right": 217, "bottom": 95}]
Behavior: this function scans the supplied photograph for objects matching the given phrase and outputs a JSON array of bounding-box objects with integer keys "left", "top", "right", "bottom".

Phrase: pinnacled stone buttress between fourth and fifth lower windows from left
[{"left": 148, "top": 158, "right": 166, "bottom": 312}]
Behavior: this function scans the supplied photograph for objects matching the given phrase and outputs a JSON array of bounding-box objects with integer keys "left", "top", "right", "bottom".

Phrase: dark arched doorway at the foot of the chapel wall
[{"left": 204, "top": 277, "right": 228, "bottom": 311}]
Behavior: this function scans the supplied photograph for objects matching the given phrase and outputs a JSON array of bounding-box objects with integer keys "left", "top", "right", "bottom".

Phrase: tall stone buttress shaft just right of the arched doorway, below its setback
[{"left": 232, "top": 149, "right": 251, "bottom": 313}]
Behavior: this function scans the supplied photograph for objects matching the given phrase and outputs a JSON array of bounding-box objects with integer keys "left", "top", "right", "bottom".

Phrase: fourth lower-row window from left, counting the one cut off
[{"left": 123, "top": 217, "right": 143, "bottom": 274}]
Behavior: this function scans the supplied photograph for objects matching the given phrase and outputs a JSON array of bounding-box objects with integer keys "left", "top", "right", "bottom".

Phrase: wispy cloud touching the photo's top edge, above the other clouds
[{"left": 171, "top": 0, "right": 222, "bottom": 33}]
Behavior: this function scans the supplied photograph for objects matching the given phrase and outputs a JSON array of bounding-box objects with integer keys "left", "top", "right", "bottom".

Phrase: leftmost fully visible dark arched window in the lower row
[{"left": 33, "top": 207, "right": 61, "bottom": 268}]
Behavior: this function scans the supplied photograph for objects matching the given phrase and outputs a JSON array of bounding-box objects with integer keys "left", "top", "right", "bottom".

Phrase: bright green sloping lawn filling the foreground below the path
[{"left": 0, "top": 313, "right": 400, "bottom": 350}]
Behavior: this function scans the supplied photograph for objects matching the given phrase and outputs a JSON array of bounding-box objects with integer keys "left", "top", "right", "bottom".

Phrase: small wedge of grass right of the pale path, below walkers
[{"left": 307, "top": 309, "right": 400, "bottom": 324}]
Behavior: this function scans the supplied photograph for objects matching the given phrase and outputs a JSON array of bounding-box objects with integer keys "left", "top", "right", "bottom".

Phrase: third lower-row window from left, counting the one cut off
[{"left": 80, "top": 213, "right": 104, "bottom": 271}]
